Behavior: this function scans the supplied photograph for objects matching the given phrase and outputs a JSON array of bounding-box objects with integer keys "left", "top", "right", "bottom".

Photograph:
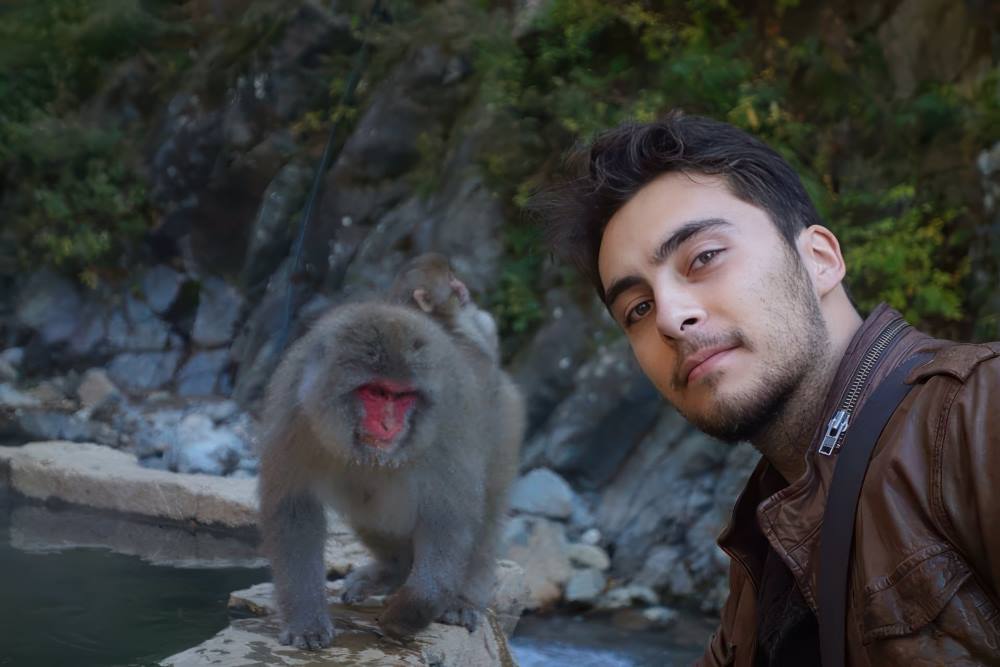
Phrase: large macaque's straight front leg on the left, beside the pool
[{"left": 261, "top": 493, "right": 334, "bottom": 650}]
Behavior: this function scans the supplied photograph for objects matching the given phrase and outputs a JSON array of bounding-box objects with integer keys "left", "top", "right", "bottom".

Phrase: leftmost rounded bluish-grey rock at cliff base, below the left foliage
[{"left": 16, "top": 269, "right": 83, "bottom": 345}]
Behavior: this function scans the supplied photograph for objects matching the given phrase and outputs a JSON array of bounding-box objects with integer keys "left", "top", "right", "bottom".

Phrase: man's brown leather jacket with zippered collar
[{"left": 696, "top": 306, "right": 1000, "bottom": 667}]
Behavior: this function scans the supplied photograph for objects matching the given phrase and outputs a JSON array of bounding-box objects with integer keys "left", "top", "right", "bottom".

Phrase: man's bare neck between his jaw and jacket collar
[{"left": 753, "top": 306, "right": 862, "bottom": 484}]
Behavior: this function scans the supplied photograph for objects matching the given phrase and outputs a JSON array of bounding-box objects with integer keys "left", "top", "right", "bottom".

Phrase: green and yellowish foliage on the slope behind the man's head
[{"left": 476, "top": 0, "right": 1000, "bottom": 333}]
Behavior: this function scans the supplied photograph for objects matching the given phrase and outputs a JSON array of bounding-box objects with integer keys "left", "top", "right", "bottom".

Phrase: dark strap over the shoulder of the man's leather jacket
[{"left": 818, "top": 353, "right": 934, "bottom": 667}]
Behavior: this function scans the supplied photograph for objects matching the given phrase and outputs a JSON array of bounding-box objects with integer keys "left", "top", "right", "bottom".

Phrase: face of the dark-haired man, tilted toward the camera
[{"left": 598, "top": 173, "right": 829, "bottom": 441}]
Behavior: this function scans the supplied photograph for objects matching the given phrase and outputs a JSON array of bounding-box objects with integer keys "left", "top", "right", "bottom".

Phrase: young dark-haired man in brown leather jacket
[{"left": 546, "top": 114, "right": 1000, "bottom": 667}]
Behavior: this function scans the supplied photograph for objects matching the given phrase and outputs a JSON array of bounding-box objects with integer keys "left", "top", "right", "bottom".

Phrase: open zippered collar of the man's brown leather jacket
[{"left": 719, "top": 304, "right": 932, "bottom": 612}]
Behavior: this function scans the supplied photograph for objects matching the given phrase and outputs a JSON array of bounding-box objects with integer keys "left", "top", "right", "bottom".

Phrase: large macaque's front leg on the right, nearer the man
[{"left": 379, "top": 507, "right": 476, "bottom": 637}]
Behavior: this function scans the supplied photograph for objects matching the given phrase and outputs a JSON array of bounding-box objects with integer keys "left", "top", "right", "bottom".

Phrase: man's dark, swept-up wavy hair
[{"left": 532, "top": 112, "right": 820, "bottom": 301}]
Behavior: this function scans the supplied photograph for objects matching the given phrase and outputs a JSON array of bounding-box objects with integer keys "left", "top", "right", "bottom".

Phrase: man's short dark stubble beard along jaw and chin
[{"left": 680, "top": 251, "right": 830, "bottom": 443}]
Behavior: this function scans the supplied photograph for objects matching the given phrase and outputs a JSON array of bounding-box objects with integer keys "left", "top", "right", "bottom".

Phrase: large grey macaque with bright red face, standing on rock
[{"left": 259, "top": 302, "right": 524, "bottom": 649}]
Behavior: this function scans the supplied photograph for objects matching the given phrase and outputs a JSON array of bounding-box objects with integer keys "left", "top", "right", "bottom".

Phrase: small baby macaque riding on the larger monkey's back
[{"left": 389, "top": 253, "right": 500, "bottom": 364}]
